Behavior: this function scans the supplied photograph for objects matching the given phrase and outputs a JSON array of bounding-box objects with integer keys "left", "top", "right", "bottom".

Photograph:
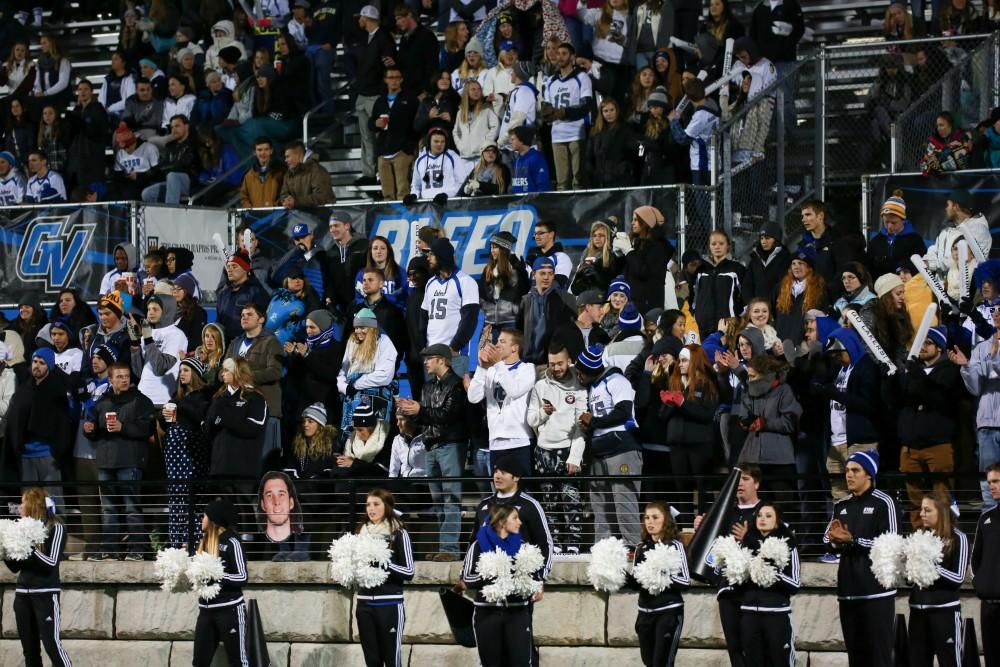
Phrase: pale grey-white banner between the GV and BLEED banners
[{"left": 142, "top": 206, "right": 232, "bottom": 303}]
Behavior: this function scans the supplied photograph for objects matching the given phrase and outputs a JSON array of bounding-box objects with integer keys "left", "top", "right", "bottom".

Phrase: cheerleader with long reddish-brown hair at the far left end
[{"left": 4, "top": 486, "right": 73, "bottom": 667}]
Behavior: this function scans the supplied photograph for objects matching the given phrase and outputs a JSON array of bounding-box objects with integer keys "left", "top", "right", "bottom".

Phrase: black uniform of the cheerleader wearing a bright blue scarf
[{"left": 462, "top": 538, "right": 544, "bottom": 667}]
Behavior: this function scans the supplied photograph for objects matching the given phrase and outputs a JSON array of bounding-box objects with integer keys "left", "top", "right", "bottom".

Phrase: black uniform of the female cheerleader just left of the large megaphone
[{"left": 629, "top": 537, "right": 691, "bottom": 667}]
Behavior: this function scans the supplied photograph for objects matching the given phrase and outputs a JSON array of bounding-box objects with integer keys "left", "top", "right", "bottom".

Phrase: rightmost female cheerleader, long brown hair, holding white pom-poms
[{"left": 909, "top": 491, "right": 969, "bottom": 667}]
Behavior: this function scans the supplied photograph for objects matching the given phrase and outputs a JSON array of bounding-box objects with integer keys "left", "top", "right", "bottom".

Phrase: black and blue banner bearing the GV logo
[{"left": 0, "top": 204, "right": 132, "bottom": 307}]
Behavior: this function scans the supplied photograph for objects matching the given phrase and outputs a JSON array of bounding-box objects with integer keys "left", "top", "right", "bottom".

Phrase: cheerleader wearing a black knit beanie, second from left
[{"left": 192, "top": 498, "right": 250, "bottom": 667}]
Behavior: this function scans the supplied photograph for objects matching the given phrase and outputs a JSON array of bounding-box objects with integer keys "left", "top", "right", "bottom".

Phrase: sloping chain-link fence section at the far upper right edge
[{"left": 891, "top": 34, "right": 1000, "bottom": 172}]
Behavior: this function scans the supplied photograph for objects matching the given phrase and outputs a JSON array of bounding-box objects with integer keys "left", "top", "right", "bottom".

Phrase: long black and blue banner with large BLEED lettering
[{"left": 240, "top": 188, "right": 677, "bottom": 277}]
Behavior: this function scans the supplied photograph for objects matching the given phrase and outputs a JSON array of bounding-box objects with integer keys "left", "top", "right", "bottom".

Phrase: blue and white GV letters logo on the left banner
[{"left": 17, "top": 215, "right": 97, "bottom": 292}]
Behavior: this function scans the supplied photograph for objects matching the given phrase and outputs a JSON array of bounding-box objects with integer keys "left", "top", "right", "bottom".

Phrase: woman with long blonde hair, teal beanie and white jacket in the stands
[{"left": 337, "top": 308, "right": 399, "bottom": 437}]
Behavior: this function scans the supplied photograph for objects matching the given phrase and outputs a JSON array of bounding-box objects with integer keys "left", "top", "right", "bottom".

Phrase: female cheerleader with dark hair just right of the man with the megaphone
[{"left": 740, "top": 503, "right": 802, "bottom": 667}]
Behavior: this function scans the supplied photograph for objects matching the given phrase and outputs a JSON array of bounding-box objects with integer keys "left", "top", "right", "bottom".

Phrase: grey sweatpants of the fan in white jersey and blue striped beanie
[{"left": 590, "top": 451, "right": 642, "bottom": 545}]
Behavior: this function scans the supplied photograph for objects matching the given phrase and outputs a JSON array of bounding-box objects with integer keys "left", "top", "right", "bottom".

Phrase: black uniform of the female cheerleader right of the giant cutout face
[{"left": 354, "top": 524, "right": 414, "bottom": 667}]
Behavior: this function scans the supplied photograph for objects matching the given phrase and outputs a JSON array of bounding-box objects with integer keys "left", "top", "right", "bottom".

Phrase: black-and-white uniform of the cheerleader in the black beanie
[{"left": 192, "top": 528, "right": 250, "bottom": 667}]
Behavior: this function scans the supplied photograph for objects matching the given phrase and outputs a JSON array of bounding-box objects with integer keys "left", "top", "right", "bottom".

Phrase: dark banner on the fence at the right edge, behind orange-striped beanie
[{"left": 868, "top": 171, "right": 1000, "bottom": 252}]
